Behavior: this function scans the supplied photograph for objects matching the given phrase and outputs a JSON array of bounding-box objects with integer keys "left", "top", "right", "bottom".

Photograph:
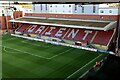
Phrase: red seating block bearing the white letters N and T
[{"left": 62, "top": 28, "right": 95, "bottom": 42}]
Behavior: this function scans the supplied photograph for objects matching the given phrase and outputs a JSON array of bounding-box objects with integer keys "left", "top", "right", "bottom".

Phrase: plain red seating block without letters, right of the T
[{"left": 92, "top": 30, "right": 113, "bottom": 46}]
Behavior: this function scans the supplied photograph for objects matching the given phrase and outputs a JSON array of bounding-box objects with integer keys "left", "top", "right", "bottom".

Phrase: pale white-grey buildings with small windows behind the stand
[{"left": 32, "top": 4, "right": 120, "bottom": 15}]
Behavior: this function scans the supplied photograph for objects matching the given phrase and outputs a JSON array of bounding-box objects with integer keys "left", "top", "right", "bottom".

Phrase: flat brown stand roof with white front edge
[{"left": 10, "top": 17, "right": 115, "bottom": 30}]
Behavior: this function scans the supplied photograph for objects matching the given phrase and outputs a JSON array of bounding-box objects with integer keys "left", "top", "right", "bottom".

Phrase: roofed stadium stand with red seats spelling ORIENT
[{"left": 10, "top": 16, "right": 116, "bottom": 51}]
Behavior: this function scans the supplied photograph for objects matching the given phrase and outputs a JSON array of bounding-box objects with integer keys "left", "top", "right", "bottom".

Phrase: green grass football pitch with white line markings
[{"left": 2, "top": 35, "right": 106, "bottom": 79}]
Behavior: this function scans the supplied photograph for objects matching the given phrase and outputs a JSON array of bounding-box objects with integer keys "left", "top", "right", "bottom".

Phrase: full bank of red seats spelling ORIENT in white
[{"left": 18, "top": 24, "right": 114, "bottom": 46}]
